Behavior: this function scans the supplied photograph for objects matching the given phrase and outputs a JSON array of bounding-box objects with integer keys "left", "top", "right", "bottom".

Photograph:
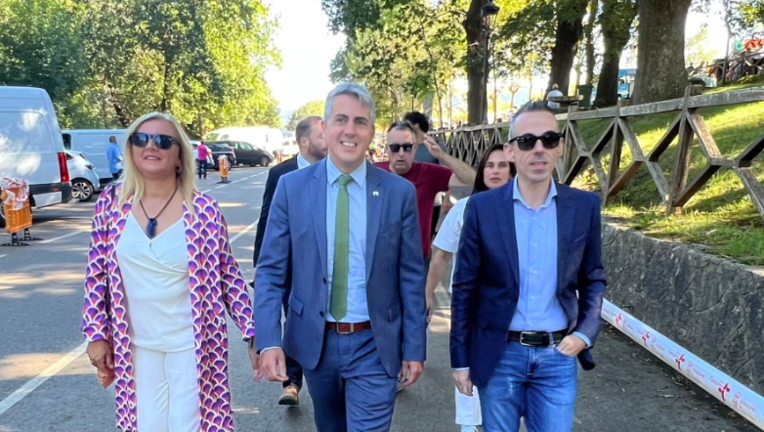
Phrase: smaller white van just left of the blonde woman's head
[{"left": 62, "top": 129, "right": 127, "bottom": 185}]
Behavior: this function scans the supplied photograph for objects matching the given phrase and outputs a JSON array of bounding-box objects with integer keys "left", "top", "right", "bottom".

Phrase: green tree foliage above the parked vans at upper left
[{"left": 0, "top": 0, "right": 280, "bottom": 134}]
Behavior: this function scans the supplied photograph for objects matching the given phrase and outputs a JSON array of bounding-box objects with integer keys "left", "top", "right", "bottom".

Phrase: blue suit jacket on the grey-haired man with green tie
[{"left": 254, "top": 161, "right": 427, "bottom": 377}]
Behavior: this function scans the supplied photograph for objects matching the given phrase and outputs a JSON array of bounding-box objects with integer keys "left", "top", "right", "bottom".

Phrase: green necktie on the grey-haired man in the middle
[{"left": 330, "top": 174, "right": 353, "bottom": 321}]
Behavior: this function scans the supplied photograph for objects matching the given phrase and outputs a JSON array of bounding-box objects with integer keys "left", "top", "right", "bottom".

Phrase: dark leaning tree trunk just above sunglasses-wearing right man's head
[{"left": 547, "top": 0, "right": 589, "bottom": 95}]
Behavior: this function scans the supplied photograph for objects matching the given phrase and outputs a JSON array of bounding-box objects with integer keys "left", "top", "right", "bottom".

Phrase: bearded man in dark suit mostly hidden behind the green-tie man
[{"left": 251, "top": 116, "right": 326, "bottom": 406}]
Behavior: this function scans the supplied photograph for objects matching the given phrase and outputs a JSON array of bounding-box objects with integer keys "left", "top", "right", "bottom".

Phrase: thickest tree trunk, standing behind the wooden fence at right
[{"left": 633, "top": 0, "right": 692, "bottom": 104}]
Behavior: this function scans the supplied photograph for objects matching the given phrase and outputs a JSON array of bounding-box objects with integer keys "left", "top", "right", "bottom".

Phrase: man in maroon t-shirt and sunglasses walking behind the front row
[{"left": 376, "top": 121, "right": 475, "bottom": 263}]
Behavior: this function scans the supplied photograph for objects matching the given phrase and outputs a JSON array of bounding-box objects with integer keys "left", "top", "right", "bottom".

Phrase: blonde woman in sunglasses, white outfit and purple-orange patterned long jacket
[{"left": 82, "top": 113, "right": 257, "bottom": 432}]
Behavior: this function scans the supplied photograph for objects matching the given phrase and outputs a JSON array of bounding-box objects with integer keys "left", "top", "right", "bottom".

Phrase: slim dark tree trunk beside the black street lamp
[{"left": 462, "top": 0, "right": 488, "bottom": 126}]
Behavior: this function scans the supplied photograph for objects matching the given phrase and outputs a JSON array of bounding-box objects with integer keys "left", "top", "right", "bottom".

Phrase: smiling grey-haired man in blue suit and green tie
[{"left": 255, "top": 84, "right": 426, "bottom": 432}]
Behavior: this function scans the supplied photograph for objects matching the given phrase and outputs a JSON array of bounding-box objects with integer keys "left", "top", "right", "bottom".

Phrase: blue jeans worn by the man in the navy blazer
[{"left": 478, "top": 342, "right": 578, "bottom": 432}]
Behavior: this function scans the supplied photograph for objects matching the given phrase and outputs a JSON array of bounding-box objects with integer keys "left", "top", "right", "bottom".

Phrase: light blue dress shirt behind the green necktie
[{"left": 324, "top": 157, "right": 369, "bottom": 323}]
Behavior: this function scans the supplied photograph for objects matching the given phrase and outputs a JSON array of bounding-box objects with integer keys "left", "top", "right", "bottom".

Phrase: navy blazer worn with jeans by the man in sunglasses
[{"left": 451, "top": 182, "right": 607, "bottom": 387}]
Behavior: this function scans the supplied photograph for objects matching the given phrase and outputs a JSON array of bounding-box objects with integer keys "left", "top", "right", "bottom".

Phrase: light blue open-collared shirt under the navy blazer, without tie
[{"left": 509, "top": 180, "right": 591, "bottom": 346}]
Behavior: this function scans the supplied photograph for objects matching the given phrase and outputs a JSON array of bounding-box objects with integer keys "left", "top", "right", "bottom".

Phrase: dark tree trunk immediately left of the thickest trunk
[{"left": 594, "top": 0, "right": 637, "bottom": 108}]
